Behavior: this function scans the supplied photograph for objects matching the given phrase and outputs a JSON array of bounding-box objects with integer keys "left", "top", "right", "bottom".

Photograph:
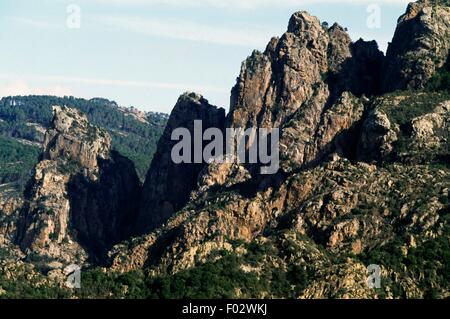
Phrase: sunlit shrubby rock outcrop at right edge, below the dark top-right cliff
[{"left": 357, "top": 92, "right": 450, "bottom": 164}]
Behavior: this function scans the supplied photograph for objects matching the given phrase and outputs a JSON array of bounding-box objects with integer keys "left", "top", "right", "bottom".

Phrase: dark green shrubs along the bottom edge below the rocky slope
[{"left": 0, "top": 243, "right": 310, "bottom": 299}]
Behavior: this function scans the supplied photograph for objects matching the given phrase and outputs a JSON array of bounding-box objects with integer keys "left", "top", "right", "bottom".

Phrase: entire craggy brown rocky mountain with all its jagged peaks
[{"left": 0, "top": 1, "right": 450, "bottom": 298}]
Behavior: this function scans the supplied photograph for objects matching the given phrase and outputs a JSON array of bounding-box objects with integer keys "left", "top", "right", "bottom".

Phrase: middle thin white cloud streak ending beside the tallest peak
[{"left": 95, "top": 16, "right": 268, "bottom": 48}]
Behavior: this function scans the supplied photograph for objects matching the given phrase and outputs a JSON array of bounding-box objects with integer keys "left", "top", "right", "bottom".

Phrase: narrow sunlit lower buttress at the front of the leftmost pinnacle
[{"left": 17, "top": 160, "right": 88, "bottom": 265}]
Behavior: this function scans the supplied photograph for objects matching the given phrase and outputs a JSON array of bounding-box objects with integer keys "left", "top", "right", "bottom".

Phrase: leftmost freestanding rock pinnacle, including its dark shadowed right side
[{"left": 17, "top": 107, "right": 140, "bottom": 266}]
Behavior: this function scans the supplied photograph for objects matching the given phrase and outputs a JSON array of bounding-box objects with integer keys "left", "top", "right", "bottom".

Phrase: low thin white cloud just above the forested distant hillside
[{"left": 0, "top": 74, "right": 229, "bottom": 95}]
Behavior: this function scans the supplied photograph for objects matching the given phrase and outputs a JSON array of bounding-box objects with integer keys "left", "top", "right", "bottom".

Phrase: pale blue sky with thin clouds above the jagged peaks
[{"left": 0, "top": 0, "right": 408, "bottom": 112}]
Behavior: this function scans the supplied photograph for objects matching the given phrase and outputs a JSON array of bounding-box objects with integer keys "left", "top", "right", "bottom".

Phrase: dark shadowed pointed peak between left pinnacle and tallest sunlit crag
[{"left": 137, "top": 93, "right": 225, "bottom": 232}]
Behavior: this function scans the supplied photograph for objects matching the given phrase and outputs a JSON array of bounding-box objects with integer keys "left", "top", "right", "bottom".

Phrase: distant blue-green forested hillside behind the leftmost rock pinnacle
[{"left": 0, "top": 96, "right": 168, "bottom": 188}]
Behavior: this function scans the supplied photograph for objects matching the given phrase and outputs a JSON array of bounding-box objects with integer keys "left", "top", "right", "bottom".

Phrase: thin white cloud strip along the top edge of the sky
[{"left": 91, "top": 0, "right": 411, "bottom": 9}]
